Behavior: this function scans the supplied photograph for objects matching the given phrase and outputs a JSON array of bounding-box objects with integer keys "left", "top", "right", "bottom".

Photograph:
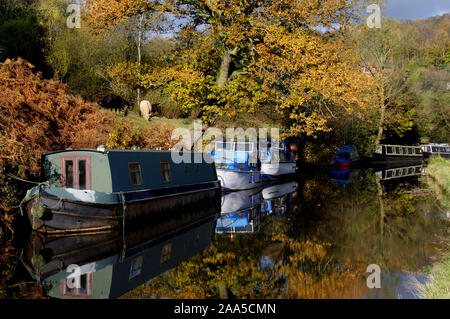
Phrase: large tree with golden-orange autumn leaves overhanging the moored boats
[{"left": 83, "top": 0, "right": 376, "bottom": 135}]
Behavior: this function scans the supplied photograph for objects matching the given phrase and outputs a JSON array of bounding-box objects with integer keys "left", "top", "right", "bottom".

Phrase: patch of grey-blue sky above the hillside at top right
[{"left": 384, "top": 0, "right": 450, "bottom": 20}]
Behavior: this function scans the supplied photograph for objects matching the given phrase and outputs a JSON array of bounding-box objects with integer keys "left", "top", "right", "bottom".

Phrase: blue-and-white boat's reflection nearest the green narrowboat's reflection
[{"left": 216, "top": 187, "right": 261, "bottom": 234}]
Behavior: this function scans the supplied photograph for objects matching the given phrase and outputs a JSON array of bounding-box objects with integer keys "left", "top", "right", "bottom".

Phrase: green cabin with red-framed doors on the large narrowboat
[{"left": 41, "top": 149, "right": 217, "bottom": 193}]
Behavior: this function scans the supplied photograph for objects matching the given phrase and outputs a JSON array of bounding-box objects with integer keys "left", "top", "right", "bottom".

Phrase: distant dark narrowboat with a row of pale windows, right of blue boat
[{"left": 370, "top": 145, "right": 423, "bottom": 164}]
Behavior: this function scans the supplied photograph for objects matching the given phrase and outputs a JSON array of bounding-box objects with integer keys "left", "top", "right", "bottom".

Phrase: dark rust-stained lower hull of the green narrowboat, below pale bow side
[{"left": 23, "top": 182, "right": 220, "bottom": 235}]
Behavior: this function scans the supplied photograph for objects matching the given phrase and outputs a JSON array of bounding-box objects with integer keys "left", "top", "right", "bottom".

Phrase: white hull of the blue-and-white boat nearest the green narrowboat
[{"left": 217, "top": 168, "right": 262, "bottom": 191}]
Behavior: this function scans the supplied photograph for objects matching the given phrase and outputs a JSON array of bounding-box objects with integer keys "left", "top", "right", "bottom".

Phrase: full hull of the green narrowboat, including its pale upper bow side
[{"left": 21, "top": 181, "right": 221, "bottom": 235}]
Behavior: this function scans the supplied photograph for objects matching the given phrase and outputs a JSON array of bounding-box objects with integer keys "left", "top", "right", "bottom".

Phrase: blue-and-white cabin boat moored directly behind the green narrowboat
[{"left": 211, "top": 140, "right": 261, "bottom": 191}]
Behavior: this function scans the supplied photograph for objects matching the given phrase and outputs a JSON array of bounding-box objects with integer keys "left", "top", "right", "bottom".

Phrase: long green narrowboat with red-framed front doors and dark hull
[{"left": 21, "top": 147, "right": 220, "bottom": 234}]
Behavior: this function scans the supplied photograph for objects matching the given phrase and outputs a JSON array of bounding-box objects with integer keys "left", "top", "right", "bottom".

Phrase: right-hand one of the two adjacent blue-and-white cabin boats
[{"left": 259, "top": 139, "right": 297, "bottom": 179}]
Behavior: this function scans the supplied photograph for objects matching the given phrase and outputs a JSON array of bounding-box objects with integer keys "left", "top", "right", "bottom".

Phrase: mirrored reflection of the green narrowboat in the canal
[{"left": 22, "top": 202, "right": 220, "bottom": 299}]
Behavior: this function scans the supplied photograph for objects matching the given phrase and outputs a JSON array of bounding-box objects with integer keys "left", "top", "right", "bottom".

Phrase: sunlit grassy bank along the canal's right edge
[{"left": 421, "top": 158, "right": 450, "bottom": 299}]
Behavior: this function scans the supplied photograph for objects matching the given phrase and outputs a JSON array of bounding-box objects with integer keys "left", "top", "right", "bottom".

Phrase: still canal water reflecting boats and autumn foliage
[{"left": 1, "top": 167, "right": 449, "bottom": 298}]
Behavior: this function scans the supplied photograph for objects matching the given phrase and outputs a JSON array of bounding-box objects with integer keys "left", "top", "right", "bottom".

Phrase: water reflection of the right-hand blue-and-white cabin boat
[{"left": 261, "top": 181, "right": 297, "bottom": 217}]
